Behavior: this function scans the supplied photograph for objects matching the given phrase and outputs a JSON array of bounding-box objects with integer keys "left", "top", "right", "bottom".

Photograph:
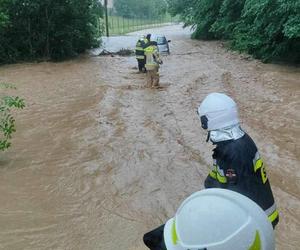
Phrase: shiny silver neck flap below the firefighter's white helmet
[{"left": 209, "top": 124, "right": 245, "bottom": 144}]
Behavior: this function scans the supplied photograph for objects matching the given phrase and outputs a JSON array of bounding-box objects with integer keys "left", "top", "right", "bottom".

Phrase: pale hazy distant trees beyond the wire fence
[{"left": 114, "top": 0, "right": 167, "bottom": 18}]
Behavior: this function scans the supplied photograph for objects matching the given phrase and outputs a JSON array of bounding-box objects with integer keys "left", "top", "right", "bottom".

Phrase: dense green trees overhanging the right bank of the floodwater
[{"left": 168, "top": 0, "right": 300, "bottom": 62}]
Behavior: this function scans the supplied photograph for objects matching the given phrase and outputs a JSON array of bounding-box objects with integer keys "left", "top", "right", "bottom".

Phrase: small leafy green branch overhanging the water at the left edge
[{"left": 0, "top": 83, "right": 25, "bottom": 151}]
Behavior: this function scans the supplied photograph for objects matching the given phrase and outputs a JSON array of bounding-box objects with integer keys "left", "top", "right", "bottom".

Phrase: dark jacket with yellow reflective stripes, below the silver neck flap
[{"left": 204, "top": 133, "right": 279, "bottom": 227}]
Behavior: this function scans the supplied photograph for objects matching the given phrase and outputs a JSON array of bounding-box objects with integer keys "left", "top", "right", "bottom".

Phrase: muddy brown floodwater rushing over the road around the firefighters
[{"left": 0, "top": 26, "right": 300, "bottom": 250}]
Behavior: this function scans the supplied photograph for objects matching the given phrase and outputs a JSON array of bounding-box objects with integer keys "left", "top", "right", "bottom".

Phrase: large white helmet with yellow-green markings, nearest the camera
[{"left": 164, "top": 188, "right": 275, "bottom": 250}]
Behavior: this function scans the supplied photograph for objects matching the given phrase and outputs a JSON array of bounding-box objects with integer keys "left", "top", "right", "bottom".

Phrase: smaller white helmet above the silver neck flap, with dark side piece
[{"left": 198, "top": 93, "right": 239, "bottom": 131}]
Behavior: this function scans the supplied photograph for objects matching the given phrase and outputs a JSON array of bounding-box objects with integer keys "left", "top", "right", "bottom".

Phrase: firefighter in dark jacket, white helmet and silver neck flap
[{"left": 197, "top": 93, "right": 279, "bottom": 227}]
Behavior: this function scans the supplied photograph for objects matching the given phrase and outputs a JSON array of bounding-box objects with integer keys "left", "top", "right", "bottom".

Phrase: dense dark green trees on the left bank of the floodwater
[{"left": 0, "top": 0, "right": 102, "bottom": 63}]
